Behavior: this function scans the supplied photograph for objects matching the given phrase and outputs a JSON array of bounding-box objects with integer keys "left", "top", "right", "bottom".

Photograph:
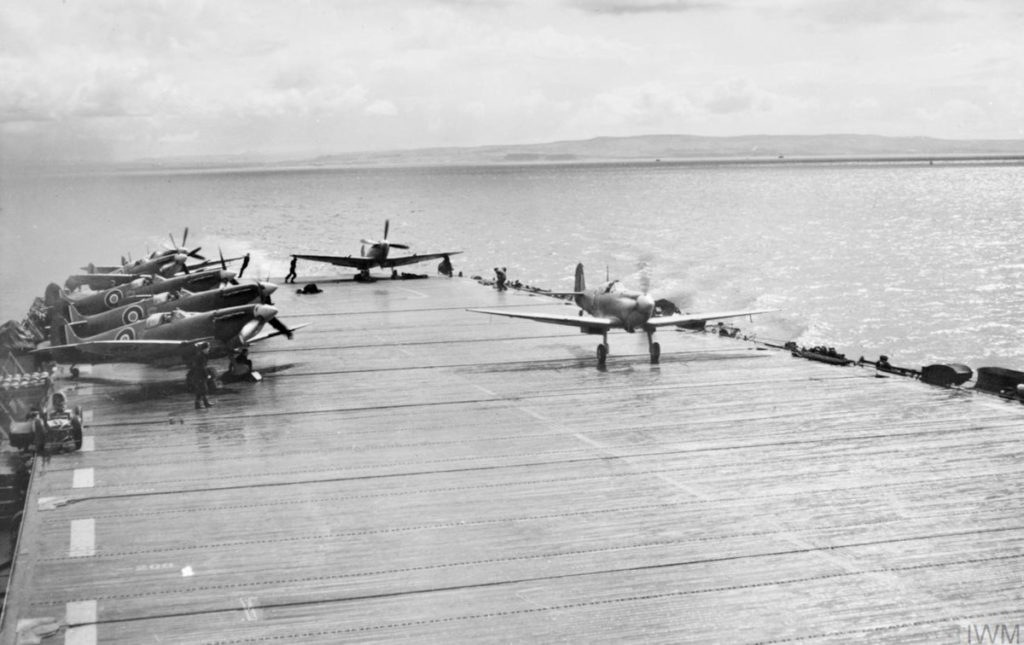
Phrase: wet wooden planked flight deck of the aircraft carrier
[{"left": 4, "top": 280, "right": 1024, "bottom": 643}]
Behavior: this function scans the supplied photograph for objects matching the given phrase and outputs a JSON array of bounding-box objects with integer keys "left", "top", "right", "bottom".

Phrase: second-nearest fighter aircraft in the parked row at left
[{"left": 68, "top": 283, "right": 278, "bottom": 337}]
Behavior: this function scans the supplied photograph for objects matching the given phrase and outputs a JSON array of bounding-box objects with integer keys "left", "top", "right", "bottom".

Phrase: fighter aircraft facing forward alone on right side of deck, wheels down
[{"left": 470, "top": 264, "right": 774, "bottom": 366}]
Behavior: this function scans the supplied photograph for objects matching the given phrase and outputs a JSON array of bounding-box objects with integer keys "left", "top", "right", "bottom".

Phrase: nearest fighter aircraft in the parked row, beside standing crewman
[{"left": 32, "top": 304, "right": 298, "bottom": 366}]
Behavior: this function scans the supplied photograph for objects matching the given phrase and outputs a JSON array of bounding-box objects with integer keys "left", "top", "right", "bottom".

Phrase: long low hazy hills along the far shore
[{"left": 122, "top": 134, "right": 1024, "bottom": 172}]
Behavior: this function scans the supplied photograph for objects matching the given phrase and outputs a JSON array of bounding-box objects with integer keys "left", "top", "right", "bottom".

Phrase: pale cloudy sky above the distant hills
[{"left": 0, "top": 0, "right": 1024, "bottom": 166}]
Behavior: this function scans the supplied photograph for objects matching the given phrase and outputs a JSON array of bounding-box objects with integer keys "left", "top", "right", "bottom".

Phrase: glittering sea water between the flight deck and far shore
[{"left": 0, "top": 162, "right": 1024, "bottom": 369}]
